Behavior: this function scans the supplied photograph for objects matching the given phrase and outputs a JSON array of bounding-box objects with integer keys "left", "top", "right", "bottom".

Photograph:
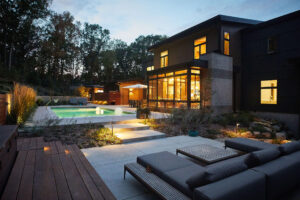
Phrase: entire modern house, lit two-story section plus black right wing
[{"left": 147, "top": 11, "right": 300, "bottom": 136}]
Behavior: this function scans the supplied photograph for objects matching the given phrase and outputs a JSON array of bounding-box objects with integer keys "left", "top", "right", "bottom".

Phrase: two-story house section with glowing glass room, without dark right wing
[{"left": 147, "top": 15, "right": 259, "bottom": 112}]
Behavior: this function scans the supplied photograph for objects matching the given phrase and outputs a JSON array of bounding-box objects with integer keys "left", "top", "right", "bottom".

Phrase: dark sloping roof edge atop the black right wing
[{"left": 243, "top": 10, "right": 300, "bottom": 32}]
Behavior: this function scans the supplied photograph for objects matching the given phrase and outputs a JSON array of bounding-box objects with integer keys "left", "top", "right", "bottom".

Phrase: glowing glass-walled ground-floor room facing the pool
[{"left": 147, "top": 60, "right": 207, "bottom": 109}]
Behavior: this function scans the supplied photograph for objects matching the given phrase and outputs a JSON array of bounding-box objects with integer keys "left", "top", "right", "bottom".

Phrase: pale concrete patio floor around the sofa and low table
[{"left": 82, "top": 136, "right": 224, "bottom": 200}]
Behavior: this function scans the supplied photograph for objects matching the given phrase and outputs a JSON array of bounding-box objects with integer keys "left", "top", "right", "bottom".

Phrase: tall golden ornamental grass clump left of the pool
[{"left": 9, "top": 83, "right": 36, "bottom": 124}]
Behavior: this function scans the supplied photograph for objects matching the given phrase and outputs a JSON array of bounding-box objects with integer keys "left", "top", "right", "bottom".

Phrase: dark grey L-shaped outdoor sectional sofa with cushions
[{"left": 125, "top": 139, "right": 300, "bottom": 200}]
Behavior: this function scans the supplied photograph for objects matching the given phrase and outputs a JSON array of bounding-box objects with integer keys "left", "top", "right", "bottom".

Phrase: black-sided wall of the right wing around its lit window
[{"left": 242, "top": 17, "right": 300, "bottom": 114}]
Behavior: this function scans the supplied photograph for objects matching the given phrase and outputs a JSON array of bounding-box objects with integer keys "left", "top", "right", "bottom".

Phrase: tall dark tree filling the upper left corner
[{"left": 0, "top": 0, "right": 51, "bottom": 76}]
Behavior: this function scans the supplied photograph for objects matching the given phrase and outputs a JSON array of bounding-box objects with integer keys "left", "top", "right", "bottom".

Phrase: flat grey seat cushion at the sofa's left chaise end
[{"left": 137, "top": 151, "right": 193, "bottom": 175}]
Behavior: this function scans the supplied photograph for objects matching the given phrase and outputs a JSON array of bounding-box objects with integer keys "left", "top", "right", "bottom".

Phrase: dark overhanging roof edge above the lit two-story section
[{"left": 148, "top": 15, "right": 262, "bottom": 50}]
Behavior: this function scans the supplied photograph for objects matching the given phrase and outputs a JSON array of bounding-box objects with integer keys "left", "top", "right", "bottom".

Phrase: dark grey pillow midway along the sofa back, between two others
[{"left": 245, "top": 148, "right": 280, "bottom": 168}]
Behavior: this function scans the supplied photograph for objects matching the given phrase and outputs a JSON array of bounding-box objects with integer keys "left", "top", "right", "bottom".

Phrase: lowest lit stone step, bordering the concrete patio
[{"left": 114, "top": 130, "right": 166, "bottom": 143}]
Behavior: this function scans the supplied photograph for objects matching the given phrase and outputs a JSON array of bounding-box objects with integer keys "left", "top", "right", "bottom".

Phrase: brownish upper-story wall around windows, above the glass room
[{"left": 153, "top": 24, "right": 219, "bottom": 69}]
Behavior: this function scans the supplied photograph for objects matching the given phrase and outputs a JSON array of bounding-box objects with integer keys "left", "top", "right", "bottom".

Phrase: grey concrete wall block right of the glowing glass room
[{"left": 201, "top": 53, "right": 233, "bottom": 114}]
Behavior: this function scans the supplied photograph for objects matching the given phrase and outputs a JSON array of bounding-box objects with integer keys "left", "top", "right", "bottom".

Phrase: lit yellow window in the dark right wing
[{"left": 260, "top": 80, "right": 277, "bottom": 104}]
